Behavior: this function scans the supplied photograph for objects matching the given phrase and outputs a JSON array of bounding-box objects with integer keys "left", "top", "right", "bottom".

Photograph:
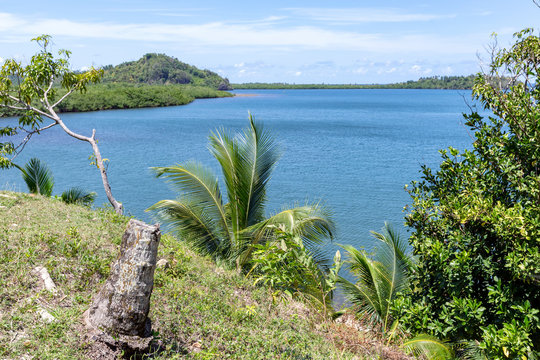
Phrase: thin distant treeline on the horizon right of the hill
[{"left": 232, "top": 75, "right": 476, "bottom": 89}]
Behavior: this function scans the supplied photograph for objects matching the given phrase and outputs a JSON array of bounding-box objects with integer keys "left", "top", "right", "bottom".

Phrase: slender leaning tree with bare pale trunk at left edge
[{"left": 0, "top": 35, "right": 123, "bottom": 214}]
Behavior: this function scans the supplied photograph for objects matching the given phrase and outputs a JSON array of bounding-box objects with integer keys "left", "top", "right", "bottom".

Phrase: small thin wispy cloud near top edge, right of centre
[{"left": 285, "top": 8, "right": 455, "bottom": 23}]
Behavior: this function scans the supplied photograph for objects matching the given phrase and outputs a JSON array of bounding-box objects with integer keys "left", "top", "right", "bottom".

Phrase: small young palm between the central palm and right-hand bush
[{"left": 338, "top": 223, "right": 413, "bottom": 335}]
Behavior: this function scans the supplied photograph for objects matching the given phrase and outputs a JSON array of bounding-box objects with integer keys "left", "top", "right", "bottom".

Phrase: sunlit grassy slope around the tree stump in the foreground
[{"left": 0, "top": 192, "right": 404, "bottom": 359}]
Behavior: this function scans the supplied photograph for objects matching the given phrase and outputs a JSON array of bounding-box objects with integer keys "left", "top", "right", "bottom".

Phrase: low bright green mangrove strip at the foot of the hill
[{"left": 0, "top": 83, "right": 232, "bottom": 116}]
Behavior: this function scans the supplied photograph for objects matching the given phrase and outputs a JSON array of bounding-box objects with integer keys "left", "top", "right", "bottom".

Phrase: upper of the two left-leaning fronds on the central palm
[{"left": 149, "top": 162, "right": 231, "bottom": 237}]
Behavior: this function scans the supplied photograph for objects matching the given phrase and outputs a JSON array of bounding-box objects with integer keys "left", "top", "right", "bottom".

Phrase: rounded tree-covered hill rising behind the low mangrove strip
[{"left": 102, "top": 53, "right": 231, "bottom": 90}]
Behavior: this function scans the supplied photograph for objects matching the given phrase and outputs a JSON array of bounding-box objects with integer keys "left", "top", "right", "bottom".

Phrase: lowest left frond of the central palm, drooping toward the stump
[{"left": 147, "top": 199, "right": 228, "bottom": 258}]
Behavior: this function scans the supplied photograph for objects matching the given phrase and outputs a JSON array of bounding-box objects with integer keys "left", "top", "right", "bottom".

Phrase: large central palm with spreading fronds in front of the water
[{"left": 148, "top": 114, "right": 334, "bottom": 270}]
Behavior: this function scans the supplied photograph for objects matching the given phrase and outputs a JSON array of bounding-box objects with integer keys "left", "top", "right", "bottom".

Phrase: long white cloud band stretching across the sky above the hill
[{"left": 0, "top": 13, "right": 477, "bottom": 54}]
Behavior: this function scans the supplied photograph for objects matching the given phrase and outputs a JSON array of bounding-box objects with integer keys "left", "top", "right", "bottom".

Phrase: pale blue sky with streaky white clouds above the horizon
[{"left": 0, "top": 0, "right": 540, "bottom": 84}]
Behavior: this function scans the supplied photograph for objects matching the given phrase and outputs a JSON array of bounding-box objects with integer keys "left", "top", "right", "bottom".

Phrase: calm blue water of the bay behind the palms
[{"left": 0, "top": 90, "right": 471, "bottom": 253}]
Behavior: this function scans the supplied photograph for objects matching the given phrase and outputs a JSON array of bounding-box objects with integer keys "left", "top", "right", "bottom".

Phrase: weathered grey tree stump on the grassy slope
[{"left": 85, "top": 219, "right": 161, "bottom": 351}]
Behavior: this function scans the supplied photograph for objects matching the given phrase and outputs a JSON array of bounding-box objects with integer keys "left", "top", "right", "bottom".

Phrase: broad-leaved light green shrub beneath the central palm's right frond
[{"left": 250, "top": 226, "right": 342, "bottom": 315}]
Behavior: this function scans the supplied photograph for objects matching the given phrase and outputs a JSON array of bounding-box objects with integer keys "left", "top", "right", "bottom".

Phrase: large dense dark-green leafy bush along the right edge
[{"left": 395, "top": 29, "right": 540, "bottom": 359}]
